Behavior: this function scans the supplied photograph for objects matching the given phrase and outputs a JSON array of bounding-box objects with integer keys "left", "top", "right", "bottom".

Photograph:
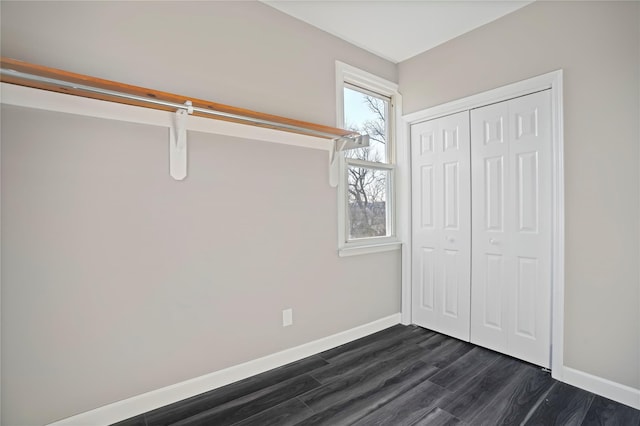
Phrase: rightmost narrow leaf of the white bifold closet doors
[{"left": 509, "top": 90, "right": 552, "bottom": 367}]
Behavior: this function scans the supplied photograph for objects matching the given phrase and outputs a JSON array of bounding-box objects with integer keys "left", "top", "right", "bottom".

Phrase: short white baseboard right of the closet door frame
[{"left": 560, "top": 366, "right": 640, "bottom": 410}]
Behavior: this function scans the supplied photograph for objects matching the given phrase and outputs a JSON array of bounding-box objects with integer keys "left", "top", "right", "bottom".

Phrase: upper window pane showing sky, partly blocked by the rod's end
[{"left": 344, "top": 87, "right": 389, "bottom": 163}]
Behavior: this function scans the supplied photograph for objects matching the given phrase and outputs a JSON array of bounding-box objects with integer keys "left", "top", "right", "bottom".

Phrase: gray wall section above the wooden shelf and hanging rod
[{"left": 0, "top": 1, "right": 397, "bottom": 125}]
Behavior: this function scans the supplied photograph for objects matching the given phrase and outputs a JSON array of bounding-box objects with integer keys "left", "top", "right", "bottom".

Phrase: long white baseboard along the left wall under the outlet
[{"left": 50, "top": 313, "right": 400, "bottom": 426}]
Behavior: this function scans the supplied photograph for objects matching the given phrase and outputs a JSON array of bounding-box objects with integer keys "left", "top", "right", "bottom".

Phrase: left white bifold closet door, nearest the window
[{"left": 411, "top": 111, "right": 471, "bottom": 341}]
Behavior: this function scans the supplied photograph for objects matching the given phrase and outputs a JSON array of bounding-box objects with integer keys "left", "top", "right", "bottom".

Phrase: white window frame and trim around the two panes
[{"left": 336, "top": 61, "right": 402, "bottom": 256}]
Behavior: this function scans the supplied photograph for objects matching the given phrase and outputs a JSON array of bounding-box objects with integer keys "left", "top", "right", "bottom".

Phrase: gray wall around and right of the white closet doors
[{"left": 399, "top": 1, "right": 640, "bottom": 388}]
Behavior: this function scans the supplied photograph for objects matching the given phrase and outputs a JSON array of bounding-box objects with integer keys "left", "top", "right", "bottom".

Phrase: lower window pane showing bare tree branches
[{"left": 347, "top": 166, "right": 390, "bottom": 240}]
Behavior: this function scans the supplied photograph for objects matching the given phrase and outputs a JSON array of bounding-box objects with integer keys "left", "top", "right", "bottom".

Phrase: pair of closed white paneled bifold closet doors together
[{"left": 411, "top": 90, "right": 552, "bottom": 368}]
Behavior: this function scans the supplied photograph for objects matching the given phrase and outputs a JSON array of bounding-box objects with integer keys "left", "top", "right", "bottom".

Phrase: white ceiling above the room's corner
[{"left": 263, "top": 0, "right": 532, "bottom": 63}]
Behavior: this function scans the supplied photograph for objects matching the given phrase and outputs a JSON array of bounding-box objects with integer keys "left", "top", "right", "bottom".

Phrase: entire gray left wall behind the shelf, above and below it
[{"left": 1, "top": 2, "right": 400, "bottom": 425}]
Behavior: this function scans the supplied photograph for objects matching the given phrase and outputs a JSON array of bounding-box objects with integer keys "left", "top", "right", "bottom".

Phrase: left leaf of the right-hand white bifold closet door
[{"left": 471, "top": 103, "right": 510, "bottom": 352}]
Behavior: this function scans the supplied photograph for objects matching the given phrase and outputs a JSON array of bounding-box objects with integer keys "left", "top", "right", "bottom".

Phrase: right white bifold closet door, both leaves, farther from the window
[{"left": 471, "top": 90, "right": 552, "bottom": 368}]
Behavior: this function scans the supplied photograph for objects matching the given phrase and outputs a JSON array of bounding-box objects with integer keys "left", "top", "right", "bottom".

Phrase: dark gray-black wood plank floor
[{"left": 117, "top": 325, "right": 640, "bottom": 426}]
